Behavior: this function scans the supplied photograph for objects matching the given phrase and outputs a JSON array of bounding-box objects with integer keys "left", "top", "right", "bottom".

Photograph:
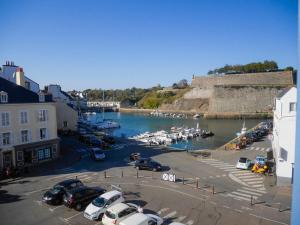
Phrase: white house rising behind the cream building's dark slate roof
[{"left": 0, "top": 61, "right": 40, "bottom": 93}]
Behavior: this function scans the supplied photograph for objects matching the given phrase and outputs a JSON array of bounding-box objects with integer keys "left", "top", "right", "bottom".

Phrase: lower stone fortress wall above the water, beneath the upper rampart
[{"left": 208, "top": 85, "right": 284, "bottom": 114}]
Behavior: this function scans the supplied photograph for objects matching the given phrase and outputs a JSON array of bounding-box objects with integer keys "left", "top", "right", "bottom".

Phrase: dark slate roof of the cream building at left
[{"left": 0, "top": 77, "right": 49, "bottom": 104}]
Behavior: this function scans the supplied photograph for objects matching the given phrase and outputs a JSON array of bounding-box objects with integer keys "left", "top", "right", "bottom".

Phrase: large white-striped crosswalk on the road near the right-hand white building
[{"left": 200, "top": 159, "right": 266, "bottom": 201}]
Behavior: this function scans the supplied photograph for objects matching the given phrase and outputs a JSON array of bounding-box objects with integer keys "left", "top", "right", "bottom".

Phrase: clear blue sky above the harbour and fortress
[{"left": 0, "top": 0, "right": 297, "bottom": 90}]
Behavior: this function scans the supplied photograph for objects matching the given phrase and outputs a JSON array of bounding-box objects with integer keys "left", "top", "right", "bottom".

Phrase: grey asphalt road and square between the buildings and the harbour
[{"left": 0, "top": 136, "right": 290, "bottom": 225}]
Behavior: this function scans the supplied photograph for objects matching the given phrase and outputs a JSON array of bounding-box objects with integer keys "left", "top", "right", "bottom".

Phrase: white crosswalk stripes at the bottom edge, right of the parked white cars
[{"left": 157, "top": 208, "right": 194, "bottom": 225}]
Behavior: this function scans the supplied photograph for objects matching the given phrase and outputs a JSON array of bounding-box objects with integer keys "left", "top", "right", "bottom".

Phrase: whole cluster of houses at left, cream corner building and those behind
[{"left": 0, "top": 62, "right": 78, "bottom": 169}]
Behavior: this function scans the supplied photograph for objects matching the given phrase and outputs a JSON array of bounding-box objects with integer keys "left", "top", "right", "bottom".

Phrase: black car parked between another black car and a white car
[{"left": 64, "top": 186, "right": 106, "bottom": 211}]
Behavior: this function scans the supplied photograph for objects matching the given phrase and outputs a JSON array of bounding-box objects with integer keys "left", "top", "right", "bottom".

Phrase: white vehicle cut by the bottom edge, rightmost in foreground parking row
[{"left": 120, "top": 213, "right": 163, "bottom": 225}]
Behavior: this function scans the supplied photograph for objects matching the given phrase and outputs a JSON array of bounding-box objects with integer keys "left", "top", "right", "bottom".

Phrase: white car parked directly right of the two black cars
[{"left": 83, "top": 191, "right": 125, "bottom": 220}]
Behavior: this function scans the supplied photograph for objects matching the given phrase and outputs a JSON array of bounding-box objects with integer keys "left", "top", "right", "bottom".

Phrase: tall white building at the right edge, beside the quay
[{"left": 272, "top": 87, "right": 297, "bottom": 185}]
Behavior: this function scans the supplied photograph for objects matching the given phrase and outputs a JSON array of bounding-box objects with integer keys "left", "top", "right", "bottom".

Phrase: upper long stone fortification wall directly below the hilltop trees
[{"left": 191, "top": 71, "right": 293, "bottom": 89}]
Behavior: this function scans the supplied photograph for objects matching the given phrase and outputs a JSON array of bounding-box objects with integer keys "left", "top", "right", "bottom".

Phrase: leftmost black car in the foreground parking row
[{"left": 43, "top": 179, "right": 83, "bottom": 205}]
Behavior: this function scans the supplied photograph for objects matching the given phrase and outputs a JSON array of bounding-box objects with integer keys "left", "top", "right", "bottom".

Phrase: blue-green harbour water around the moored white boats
[{"left": 88, "top": 112, "right": 262, "bottom": 150}]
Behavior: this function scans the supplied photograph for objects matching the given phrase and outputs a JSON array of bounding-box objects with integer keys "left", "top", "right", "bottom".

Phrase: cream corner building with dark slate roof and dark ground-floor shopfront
[{"left": 0, "top": 74, "right": 59, "bottom": 169}]
